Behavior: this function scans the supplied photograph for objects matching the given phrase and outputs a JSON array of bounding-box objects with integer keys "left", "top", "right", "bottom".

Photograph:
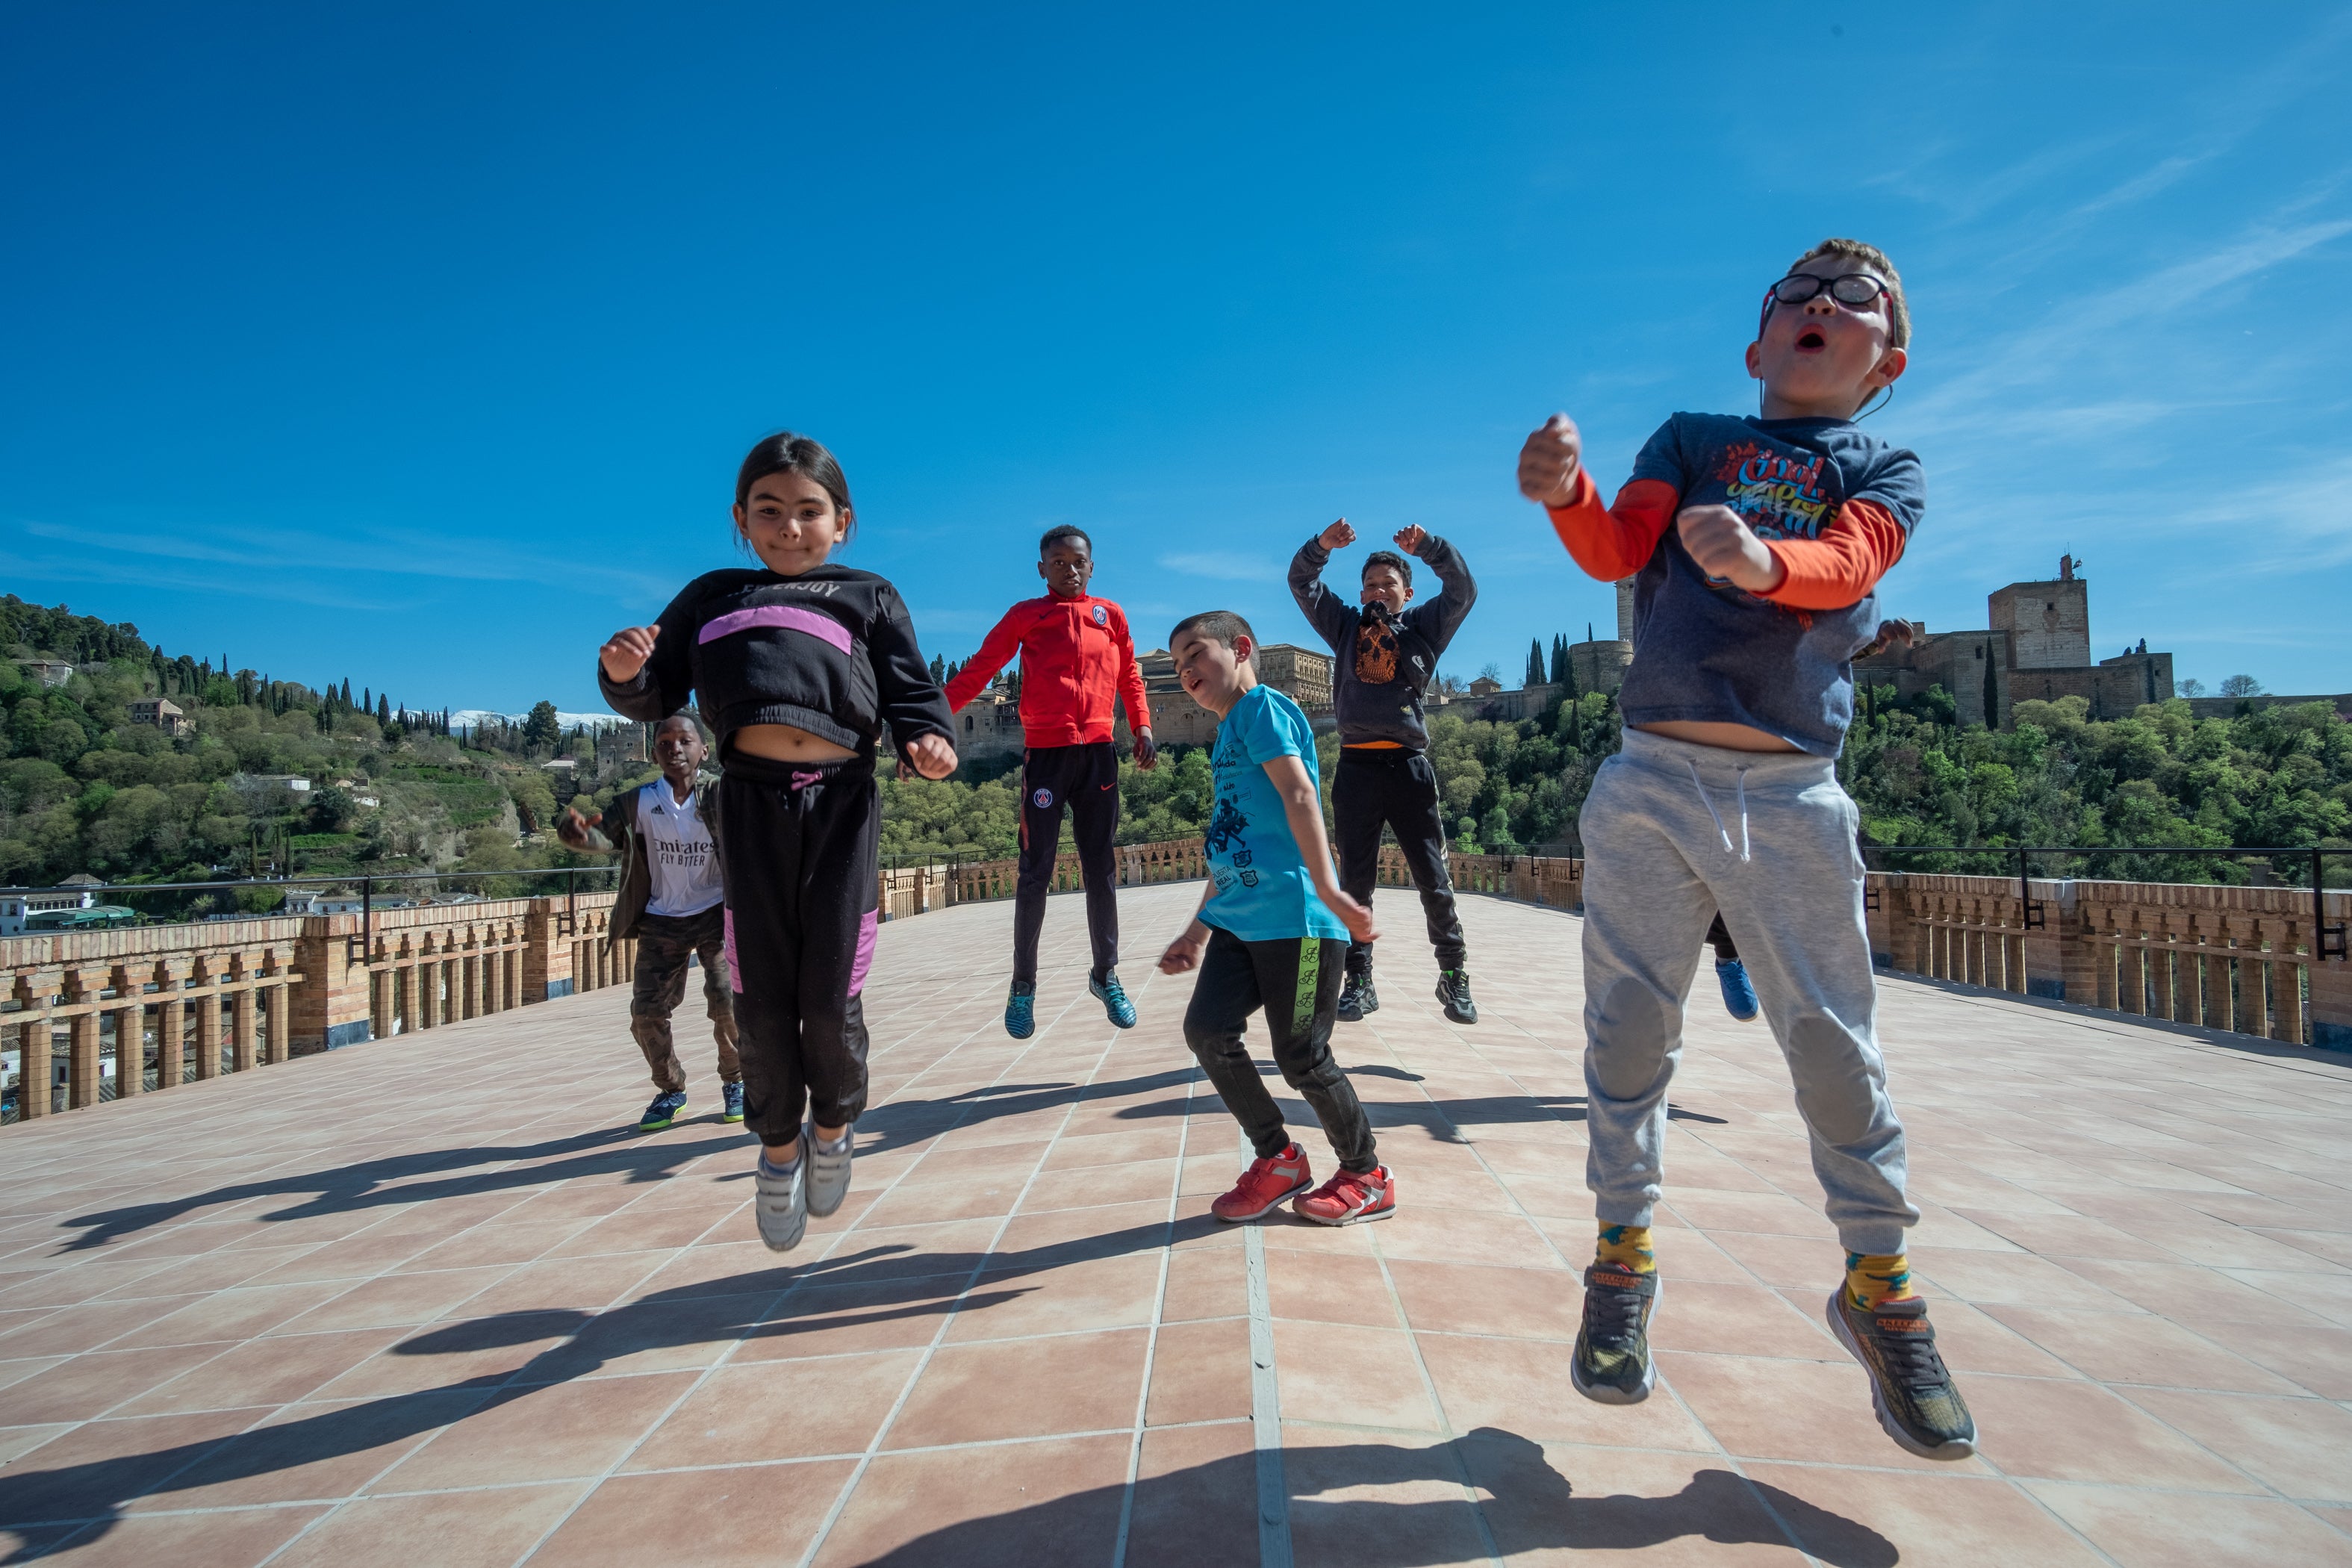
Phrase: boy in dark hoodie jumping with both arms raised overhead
[{"left": 1291, "top": 517, "right": 1477, "bottom": 1023}]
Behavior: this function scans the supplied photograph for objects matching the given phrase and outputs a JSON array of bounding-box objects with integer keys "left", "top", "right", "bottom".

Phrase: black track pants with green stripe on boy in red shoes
[{"left": 1183, "top": 926, "right": 1381, "bottom": 1173}]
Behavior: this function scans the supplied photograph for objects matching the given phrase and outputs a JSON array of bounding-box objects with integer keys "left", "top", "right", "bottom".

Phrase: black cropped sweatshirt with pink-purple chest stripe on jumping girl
[{"left": 595, "top": 561, "right": 955, "bottom": 757}]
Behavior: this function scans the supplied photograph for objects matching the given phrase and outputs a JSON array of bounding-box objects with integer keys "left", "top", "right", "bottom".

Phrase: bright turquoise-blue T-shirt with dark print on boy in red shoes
[{"left": 1200, "top": 686, "right": 1348, "bottom": 943}]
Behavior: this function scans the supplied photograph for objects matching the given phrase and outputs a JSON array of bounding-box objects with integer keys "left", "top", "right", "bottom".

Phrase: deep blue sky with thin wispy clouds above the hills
[{"left": 0, "top": 0, "right": 2352, "bottom": 708}]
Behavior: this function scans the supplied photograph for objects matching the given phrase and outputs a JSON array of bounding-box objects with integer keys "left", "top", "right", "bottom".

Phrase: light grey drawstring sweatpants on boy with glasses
[{"left": 1581, "top": 729, "right": 1919, "bottom": 1253}]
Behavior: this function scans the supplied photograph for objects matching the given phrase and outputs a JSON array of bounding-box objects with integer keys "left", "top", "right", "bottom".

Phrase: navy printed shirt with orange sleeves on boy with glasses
[{"left": 1550, "top": 414, "right": 1926, "bottom": 757}]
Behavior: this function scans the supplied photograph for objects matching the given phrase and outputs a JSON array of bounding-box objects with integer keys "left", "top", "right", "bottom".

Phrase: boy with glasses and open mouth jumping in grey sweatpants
[{"left": 1519, "top": 240, "right": 1976, "bottom": 1460}]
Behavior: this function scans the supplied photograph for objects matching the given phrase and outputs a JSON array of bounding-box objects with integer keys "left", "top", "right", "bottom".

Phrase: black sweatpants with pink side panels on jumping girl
[{"left": 718, "top": 752, "right": 882, "bottom": 1145}]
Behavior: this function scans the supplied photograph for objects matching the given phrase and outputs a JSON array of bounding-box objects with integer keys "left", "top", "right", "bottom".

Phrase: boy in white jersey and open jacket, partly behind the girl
[{"left": 555, "top": 712, "right": 743, "bottom": 1133}]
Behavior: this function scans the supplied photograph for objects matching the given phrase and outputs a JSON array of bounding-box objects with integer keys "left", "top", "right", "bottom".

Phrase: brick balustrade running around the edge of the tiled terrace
[{"left": 0, "top": 839, "right": 2352, "bottom": 1117}]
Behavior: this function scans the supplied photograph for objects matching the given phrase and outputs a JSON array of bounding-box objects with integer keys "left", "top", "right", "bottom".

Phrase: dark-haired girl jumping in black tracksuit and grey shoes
[{"left": 597, "top": 432, "right": 955, "bottom": 1253}]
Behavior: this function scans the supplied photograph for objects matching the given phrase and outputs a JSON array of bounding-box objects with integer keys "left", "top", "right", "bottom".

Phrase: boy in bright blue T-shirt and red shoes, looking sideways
[{"left": 1160, "top": 609, "right": 1397, "bottom": 1225}]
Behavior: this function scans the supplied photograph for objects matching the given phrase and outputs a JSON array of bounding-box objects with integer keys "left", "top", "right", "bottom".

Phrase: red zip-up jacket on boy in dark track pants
[{"left": 948, "top": 592, "right": 1153, "bottom": 745}]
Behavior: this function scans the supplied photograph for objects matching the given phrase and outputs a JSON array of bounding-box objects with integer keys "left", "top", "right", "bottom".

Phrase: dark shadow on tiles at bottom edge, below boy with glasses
[{"left": 863, "top": 1427, "right": 1903, "bottom": 1568}]
